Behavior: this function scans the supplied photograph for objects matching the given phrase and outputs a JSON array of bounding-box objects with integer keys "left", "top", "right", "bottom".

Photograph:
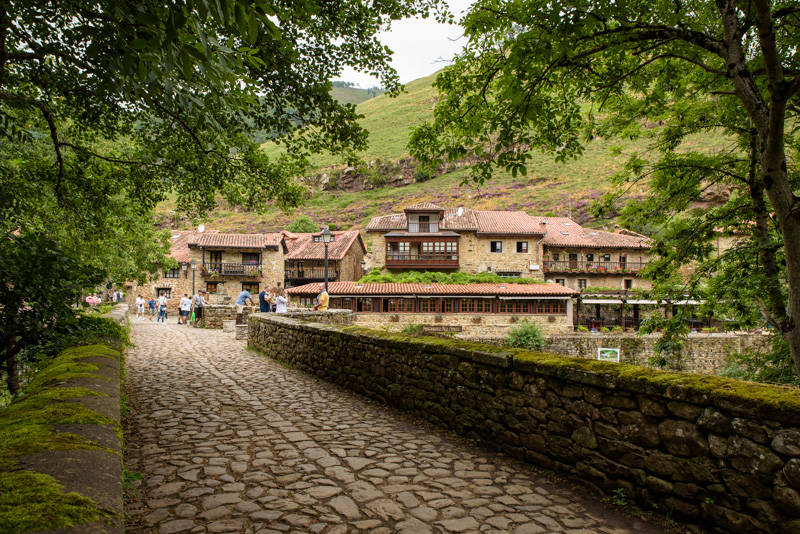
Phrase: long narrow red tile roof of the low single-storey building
[{"left": 286, "top": 282, "right": 579, "bottom": 298}]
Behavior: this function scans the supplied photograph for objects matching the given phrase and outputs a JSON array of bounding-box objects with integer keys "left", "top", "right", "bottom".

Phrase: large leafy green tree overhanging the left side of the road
[{"left": 0, "top": 0, "right": 436, "bottom": 394}]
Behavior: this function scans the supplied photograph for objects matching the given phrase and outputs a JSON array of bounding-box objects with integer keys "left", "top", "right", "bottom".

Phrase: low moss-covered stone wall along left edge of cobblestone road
[{"left": 0, "top": 309, "right": 125, "bottom": 534}]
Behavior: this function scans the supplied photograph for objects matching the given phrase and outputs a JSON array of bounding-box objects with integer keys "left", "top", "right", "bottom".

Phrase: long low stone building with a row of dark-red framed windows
[{"left": 287, "top": 282, "right": 578, "bottom": 338}]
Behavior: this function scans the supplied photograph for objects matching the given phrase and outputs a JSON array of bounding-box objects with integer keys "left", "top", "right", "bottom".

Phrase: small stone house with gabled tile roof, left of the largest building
[{"left": 283, "top": 230, "right": 367, "bottom": 287}]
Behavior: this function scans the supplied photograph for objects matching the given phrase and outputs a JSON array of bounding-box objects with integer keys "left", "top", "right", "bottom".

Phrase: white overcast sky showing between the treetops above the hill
[{"left": 338, "top": 0, "right": 474, "bottom": 88}]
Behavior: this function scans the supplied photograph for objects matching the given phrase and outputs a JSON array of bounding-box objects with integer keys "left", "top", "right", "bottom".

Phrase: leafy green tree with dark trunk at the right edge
[{"left": 411, "top": 0, "right": 800, "bottom": 376}]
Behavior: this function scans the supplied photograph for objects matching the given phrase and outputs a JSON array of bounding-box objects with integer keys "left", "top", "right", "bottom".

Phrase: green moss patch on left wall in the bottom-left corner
[{"left": 0, "top": 471, "right": 112, "bottom": 532}]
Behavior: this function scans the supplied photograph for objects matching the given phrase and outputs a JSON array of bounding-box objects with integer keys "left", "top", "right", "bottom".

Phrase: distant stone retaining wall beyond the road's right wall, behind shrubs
[{"left": 545, "top": 333, "right": 771, "bottom": 375}]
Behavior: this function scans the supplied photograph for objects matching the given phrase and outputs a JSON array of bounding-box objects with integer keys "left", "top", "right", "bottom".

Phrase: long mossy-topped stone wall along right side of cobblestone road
[{"left": 248, "top": 315, "right": 800, "bottom": 533}]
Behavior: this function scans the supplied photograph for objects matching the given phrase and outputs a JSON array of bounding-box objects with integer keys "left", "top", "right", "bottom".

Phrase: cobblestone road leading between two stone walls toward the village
[{"left": 126, "top": 319, "right": 661, "bottom": 534}]
